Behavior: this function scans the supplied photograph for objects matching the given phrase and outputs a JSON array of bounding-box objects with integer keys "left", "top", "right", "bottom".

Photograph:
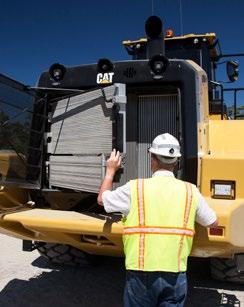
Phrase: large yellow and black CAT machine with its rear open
[{"left": 0, "top": 16, "right": 244, "bottom": 283}]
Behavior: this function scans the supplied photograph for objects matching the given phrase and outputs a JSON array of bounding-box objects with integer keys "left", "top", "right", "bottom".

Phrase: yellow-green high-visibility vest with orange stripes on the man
[{"left": 123, "top": 176, "right": 198, "bottom": 272}]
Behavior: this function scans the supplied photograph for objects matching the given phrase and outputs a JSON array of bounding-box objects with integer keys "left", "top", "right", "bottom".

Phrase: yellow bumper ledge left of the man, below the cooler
[{"left": 0, "top": 209, "right": 123, "bottom": 256}]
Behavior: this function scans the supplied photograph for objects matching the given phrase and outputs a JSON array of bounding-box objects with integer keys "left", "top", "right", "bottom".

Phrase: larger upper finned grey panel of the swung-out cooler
[{"left": 51, "top": 86, "right": 114, "bottom": 154}]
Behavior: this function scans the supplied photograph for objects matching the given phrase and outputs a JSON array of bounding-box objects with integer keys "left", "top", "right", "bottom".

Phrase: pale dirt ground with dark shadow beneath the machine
[{"left": 0, "top": 235, "right": 244, "bottom": 307}]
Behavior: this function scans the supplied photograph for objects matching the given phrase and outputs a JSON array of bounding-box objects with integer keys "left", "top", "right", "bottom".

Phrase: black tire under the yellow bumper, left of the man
[{"left": 37, "top": 243, "right": 98, "bottom": 266}]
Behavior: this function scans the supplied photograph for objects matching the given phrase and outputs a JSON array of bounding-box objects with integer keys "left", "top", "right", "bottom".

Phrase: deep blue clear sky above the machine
[{"left": 0, "top": 0, "right": 244, "bottom": 106}]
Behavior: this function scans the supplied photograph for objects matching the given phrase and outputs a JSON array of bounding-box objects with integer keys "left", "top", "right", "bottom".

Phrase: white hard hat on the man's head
[{"left": 149, "top": 133, "right": 181, "bottom": 160}]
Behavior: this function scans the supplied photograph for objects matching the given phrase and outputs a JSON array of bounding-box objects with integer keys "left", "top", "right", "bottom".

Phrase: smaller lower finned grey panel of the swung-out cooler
[{"left": 50, "top": 156, "right": 102, "bottom": 193}]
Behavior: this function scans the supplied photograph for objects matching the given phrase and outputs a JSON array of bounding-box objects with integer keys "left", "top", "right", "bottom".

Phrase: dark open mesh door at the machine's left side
[{"left": 0, "top": 75, "right": 44, "bottom": 185}]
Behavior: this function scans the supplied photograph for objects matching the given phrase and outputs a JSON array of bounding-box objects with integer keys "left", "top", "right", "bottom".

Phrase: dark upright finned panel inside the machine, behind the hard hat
[{"left": 138, "top": 94, "right": 179, "bottom": 178}]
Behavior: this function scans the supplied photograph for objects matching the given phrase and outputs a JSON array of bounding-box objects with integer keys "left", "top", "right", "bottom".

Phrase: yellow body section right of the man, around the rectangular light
[{"left": 192, "top": 120, "right": 244, "bottom": 257}]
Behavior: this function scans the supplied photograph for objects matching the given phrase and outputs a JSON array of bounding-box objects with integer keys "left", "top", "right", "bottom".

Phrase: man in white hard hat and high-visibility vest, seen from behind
[{"left": 98, "top": 133, "right": 217, "bottom": 307}]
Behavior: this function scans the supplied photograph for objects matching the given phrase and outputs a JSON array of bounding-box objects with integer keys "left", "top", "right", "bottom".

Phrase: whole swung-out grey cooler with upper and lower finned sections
[{"left": 47, "top": 84, "right": 126, "bottom": 193}]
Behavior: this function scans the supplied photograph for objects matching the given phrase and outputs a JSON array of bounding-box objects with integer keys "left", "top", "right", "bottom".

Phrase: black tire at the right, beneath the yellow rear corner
[{"left": 210, "top": 258, "right": 244, "bottom": 284}]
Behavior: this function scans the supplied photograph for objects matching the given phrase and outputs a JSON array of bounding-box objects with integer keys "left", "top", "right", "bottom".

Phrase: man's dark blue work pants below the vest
[{"left": 124, "top": 270, "right": 187, "bottom": 307}]
